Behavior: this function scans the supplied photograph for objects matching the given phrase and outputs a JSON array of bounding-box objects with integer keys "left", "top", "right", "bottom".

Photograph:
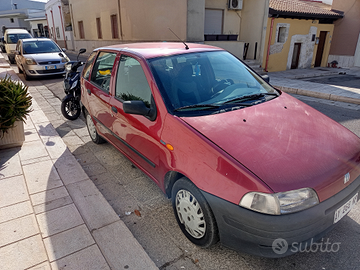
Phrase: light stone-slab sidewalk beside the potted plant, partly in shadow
[{"left": 0, "top": 54, "right": 157, "bottom": 270}]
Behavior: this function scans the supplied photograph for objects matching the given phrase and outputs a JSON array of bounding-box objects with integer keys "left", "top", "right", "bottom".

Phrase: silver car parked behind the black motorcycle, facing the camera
[{"left": 15, "top": 38, "right": 70, "bottom": 80}]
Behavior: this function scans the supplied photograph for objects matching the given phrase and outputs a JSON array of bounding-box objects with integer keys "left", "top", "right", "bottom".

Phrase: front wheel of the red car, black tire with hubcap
[{"left": 171, "top": 177, "right": 219, "bottom": 248}]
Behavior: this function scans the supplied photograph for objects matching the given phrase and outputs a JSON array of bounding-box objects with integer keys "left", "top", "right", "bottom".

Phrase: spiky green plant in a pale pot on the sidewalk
[{"left": 0, "top": 76, "right": 32, "bottom": 148}]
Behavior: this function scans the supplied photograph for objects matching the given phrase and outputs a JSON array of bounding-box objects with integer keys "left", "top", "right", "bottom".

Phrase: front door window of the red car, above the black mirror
[{"left": 115, "top": 55, "right": 151, "bottom": 108}]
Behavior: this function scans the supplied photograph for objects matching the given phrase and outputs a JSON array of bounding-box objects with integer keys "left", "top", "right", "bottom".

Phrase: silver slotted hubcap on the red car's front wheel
[{"left": 176, "top": 189, "right": 206, "bottom": 239}]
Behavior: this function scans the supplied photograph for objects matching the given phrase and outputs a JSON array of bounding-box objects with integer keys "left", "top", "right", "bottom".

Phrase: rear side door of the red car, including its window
[{"left": 82, "top": 51, "right": 117, "bottom": 140}]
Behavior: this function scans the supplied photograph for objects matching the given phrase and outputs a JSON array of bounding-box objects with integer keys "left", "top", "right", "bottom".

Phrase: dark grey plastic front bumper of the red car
[{"left": 202, "top": 176, "right": 360, "bottom": 258}]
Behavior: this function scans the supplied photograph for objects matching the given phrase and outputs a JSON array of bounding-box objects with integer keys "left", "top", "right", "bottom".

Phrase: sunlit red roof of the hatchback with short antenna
[{"left": 94, "top": 42, "right": 223, "bottom": 59}]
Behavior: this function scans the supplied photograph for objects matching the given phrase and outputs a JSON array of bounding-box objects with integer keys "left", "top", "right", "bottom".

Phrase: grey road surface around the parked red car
[{"left": 5, "top": 56, "right": 360, "bottom": 270}]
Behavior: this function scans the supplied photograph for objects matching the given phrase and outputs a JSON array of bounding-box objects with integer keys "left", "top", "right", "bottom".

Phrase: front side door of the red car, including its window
[{"left": 110, "top": 54, "right": 169, "bottom": 181}]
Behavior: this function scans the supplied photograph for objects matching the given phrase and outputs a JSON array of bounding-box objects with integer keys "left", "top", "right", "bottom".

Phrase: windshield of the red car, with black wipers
[{"left": 149, "top": 51, "right": 279, "bottom": 115}]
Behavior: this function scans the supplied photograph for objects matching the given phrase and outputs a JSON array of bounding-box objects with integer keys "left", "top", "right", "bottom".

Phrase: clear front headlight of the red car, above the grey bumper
[{"left": 240, "top": 188, "right": 319, "bottom": 215}]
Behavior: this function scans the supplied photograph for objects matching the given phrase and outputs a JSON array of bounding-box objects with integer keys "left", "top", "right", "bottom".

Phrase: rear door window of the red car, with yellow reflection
[{"left": 91, "top": 52, "right": 116, "bottom": 93}]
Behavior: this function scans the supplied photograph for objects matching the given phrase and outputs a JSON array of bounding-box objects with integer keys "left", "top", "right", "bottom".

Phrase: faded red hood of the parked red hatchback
[{"left": 182, "top": 93, "right": 360, "bottom": 201}]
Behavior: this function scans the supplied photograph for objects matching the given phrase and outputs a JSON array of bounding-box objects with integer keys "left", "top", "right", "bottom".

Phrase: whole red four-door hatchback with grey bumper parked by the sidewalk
[{"left": 81, "top": 42, "right": 360, "bottom": 257}]
